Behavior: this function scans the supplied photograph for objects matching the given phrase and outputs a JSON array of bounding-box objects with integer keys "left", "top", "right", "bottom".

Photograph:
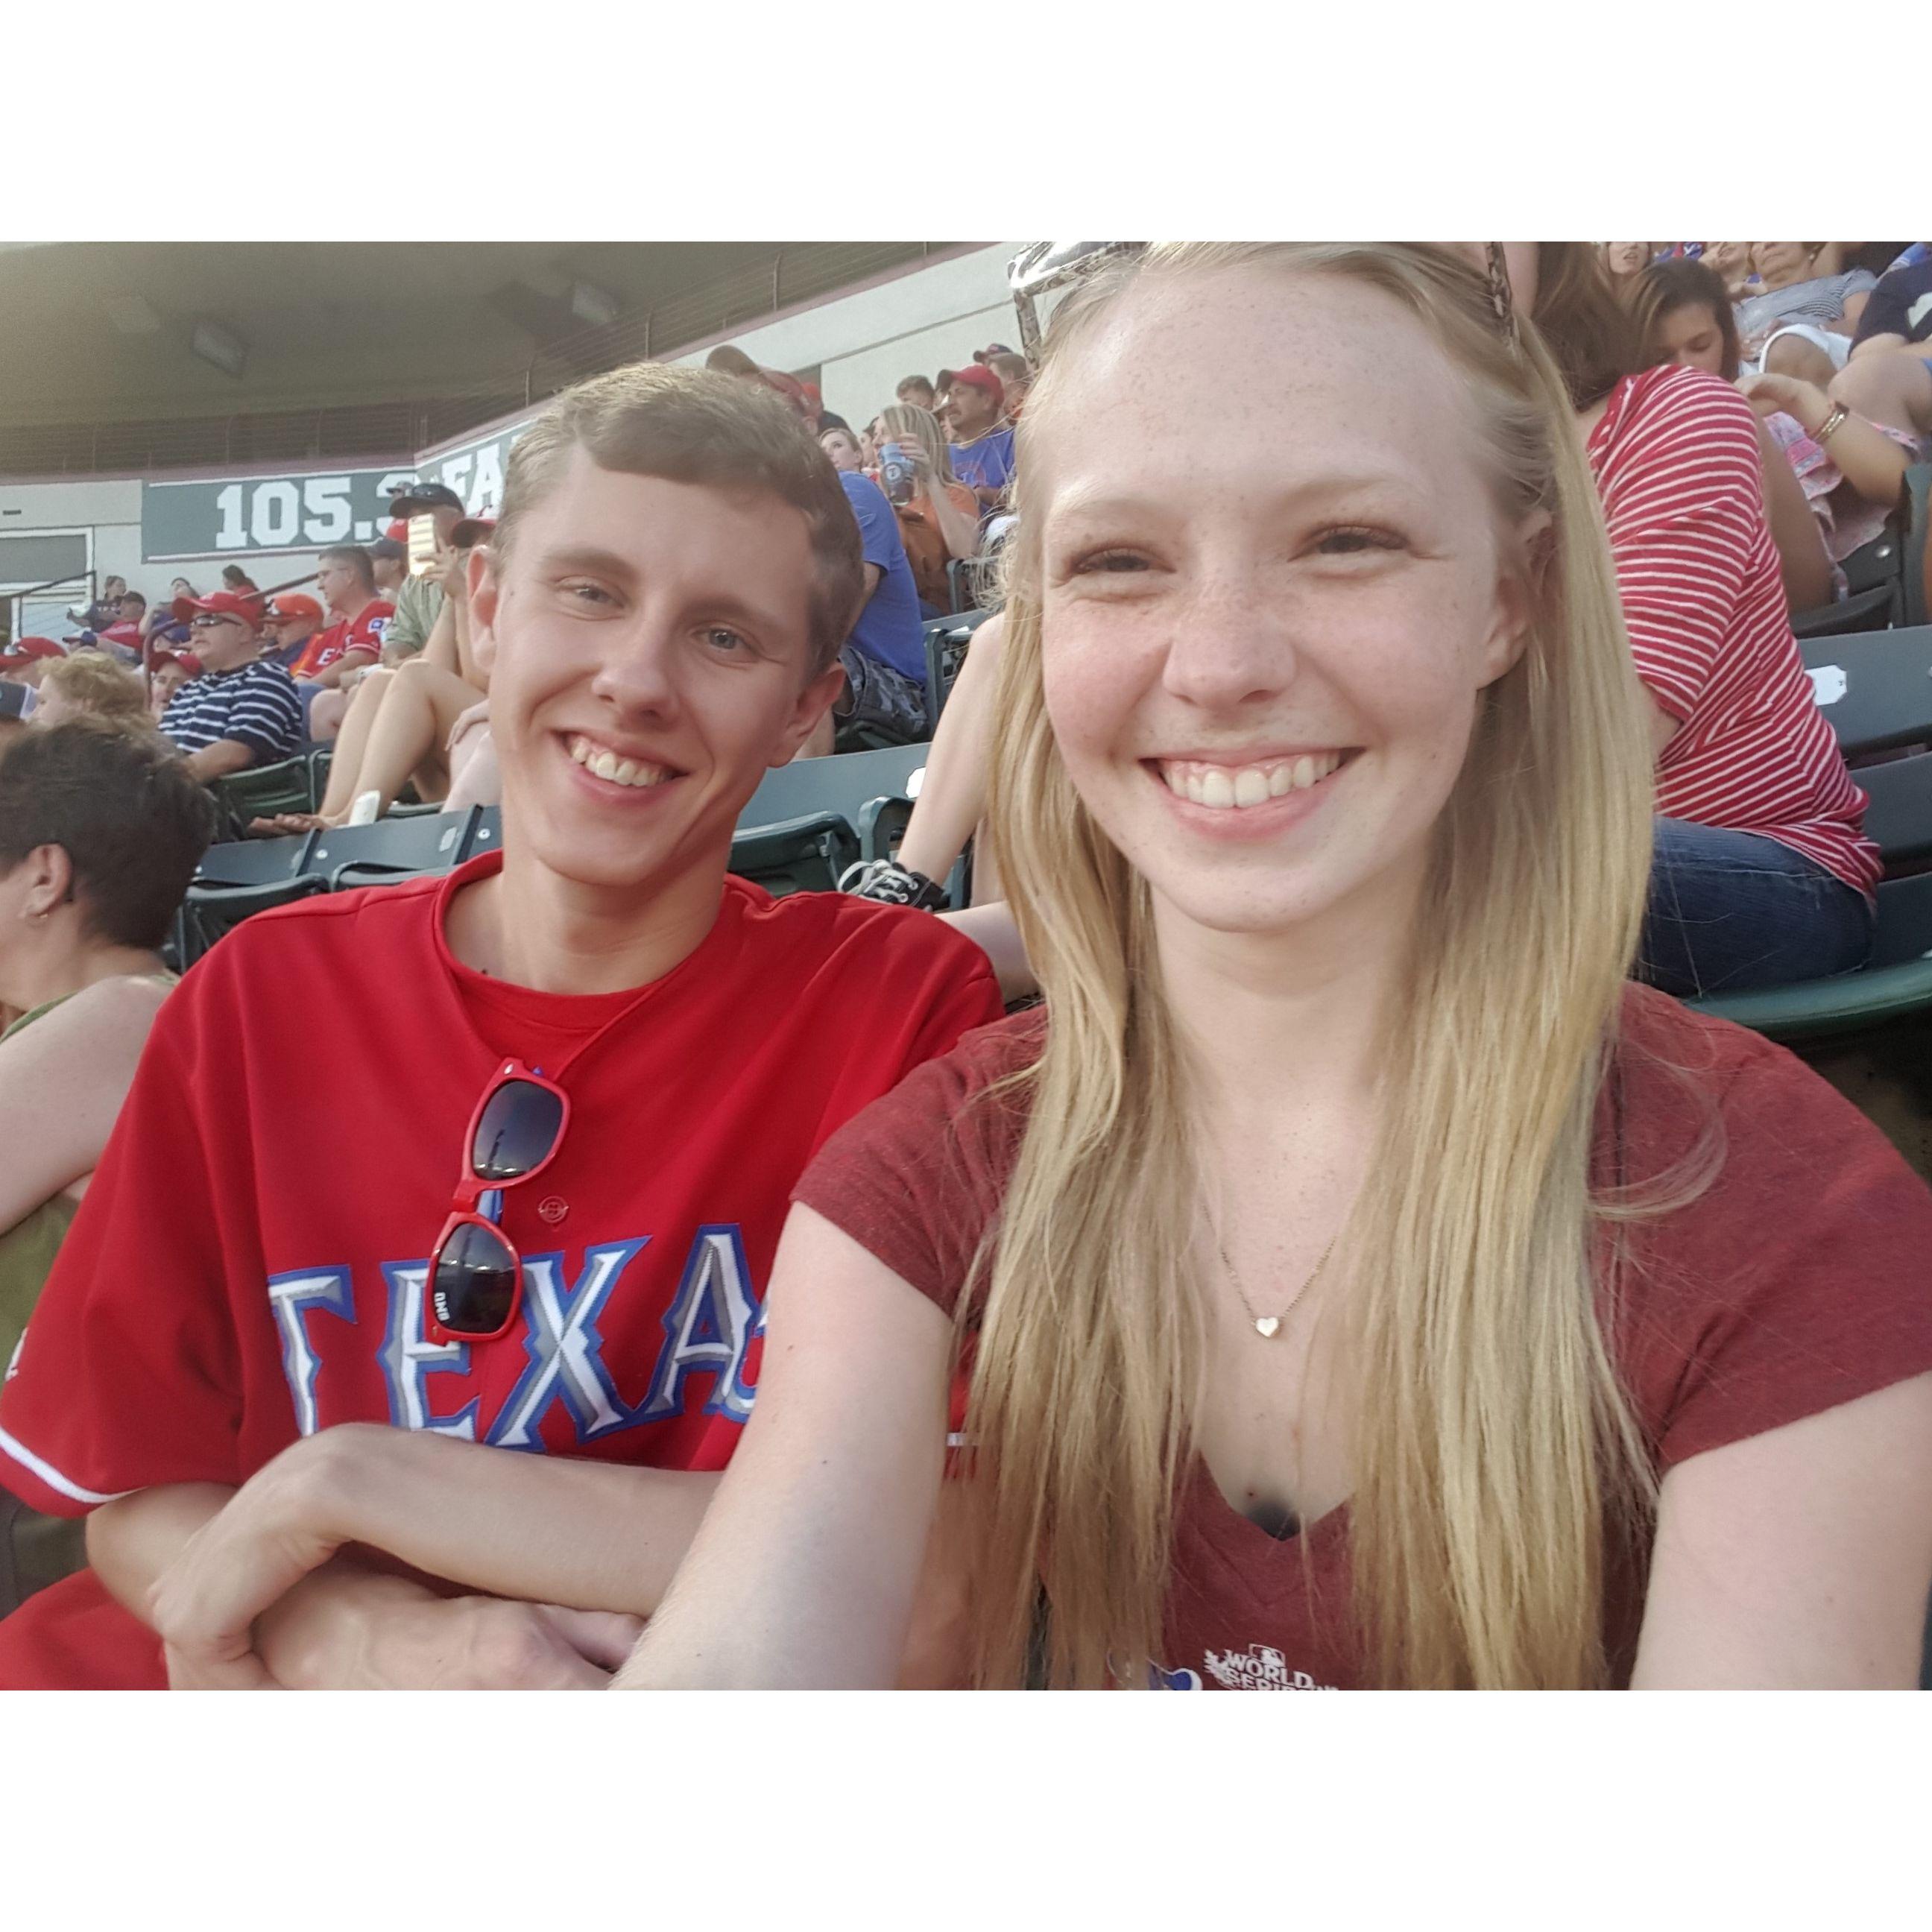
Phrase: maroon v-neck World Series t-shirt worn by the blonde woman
[{"left": 794, "top": 988, "right": 1932, "bottom": 1690}]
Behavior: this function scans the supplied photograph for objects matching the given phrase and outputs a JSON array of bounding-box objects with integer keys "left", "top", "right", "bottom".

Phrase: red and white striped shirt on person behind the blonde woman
[{"left": 1588, "top": 367, "right": 1880, "bottom": 894}]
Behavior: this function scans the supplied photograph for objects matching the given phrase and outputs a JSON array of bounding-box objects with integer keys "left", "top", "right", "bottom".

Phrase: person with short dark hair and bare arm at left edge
[{"left": 0, "top": 726, "right": 215, "bottom": 1603}]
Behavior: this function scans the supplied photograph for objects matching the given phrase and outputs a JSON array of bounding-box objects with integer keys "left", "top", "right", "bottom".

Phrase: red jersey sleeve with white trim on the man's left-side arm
[{"left": 0, "top": 949, "right": 263, "bottom": 1517}]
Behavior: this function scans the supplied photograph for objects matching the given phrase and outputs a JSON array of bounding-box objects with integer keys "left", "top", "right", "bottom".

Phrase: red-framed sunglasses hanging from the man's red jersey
[{"left": 423, "top": 1061, "right": 570, "bottom": 1342}]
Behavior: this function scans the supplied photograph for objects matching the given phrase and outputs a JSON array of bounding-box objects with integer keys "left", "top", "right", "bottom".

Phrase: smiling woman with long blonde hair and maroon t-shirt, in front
[{"left": 624, "top": 244, "right": 1932, "bottom": 1688}]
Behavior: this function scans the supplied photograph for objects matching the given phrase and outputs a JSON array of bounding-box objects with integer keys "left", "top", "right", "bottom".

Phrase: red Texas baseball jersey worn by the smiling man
[{"left": 0, "top": 854, "right": 1001, "bottom": 1685}]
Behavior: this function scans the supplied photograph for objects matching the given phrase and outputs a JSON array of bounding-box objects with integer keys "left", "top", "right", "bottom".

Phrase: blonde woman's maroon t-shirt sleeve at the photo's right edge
[{"left": 1638, "top": 1041, "right": 1932, "bottom": 1468}]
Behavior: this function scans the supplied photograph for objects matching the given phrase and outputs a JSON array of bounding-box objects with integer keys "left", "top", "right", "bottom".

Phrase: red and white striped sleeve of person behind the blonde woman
[{"left": 1598, "top": 373, "right": 1764, "bottom": 722}]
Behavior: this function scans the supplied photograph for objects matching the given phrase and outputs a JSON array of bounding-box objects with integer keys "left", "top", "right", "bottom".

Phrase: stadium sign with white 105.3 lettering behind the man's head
[{"left": 141, "top": 417, "right": 529, "bottom": 564}]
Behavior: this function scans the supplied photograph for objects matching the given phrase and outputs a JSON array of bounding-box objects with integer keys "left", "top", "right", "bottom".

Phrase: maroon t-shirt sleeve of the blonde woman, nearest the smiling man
[{"left": 792, "top": 1014, "right": 1038, "bottom": 1312}]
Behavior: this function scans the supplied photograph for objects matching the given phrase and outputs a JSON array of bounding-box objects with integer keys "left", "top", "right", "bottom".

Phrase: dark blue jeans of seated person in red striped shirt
[{"left": 1636, "top": 819, "right": 1872, "bottom": 999}]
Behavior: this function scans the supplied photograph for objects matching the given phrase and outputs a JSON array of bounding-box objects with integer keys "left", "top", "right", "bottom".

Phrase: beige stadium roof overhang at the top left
[{"left": 0, "top": 242, "right": 931, "bottom": 425}]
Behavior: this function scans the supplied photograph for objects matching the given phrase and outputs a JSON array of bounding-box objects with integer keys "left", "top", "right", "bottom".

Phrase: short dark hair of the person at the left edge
[{"left": 0, "top": 719, "right": 215, "bottom": 950}]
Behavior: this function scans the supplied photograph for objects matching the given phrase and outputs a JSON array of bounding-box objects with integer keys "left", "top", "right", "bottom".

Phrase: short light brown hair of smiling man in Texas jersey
[{"left": 490, "top": 363, "right": 865, "bottom": 676}]
